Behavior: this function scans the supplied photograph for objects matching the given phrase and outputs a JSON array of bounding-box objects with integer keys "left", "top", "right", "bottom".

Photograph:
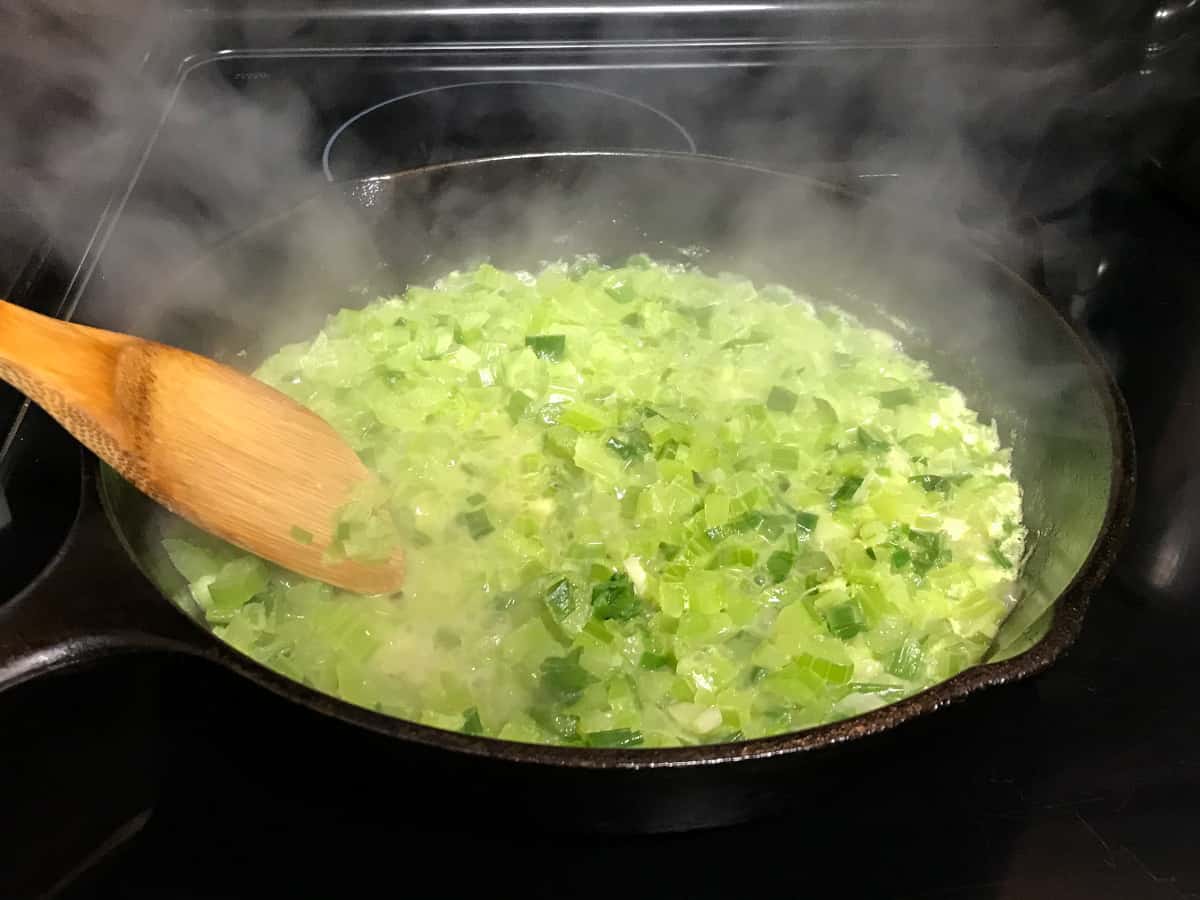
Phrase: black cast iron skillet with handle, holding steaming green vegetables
[{"left": 0, "top": 152, "right": 1133, "bottom": 829}]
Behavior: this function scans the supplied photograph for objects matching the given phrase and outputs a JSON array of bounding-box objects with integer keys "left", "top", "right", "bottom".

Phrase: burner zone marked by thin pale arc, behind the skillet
[{"left": 320, "top": 79, "right": 696, "bottom": 181}]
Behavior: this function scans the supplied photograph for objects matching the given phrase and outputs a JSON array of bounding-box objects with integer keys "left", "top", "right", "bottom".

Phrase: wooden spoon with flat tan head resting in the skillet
[{"left": 0, "top": 300, "right": 404, "bottom": 593}]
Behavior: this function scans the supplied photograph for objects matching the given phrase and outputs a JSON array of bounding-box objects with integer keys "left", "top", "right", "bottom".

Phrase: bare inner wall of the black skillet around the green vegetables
[{"left": 95, "top": 154, "right": 1117, "bottom": 724}]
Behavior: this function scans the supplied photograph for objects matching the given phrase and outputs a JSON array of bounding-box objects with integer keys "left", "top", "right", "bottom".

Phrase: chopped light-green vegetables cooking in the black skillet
[{"left": 154, "top": 256, "right": 1025, "bottom": 748}]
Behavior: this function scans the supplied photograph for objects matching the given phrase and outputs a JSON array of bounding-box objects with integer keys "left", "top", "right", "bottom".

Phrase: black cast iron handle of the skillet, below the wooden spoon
[{"left": 0, "top": 460, "right": 209, "bottom": 692}]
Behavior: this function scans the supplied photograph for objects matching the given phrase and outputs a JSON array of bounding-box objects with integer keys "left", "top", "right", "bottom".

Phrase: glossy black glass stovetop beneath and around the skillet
[{"left": 0, "top": 2, "right": 1200, "bottom": 900}]
